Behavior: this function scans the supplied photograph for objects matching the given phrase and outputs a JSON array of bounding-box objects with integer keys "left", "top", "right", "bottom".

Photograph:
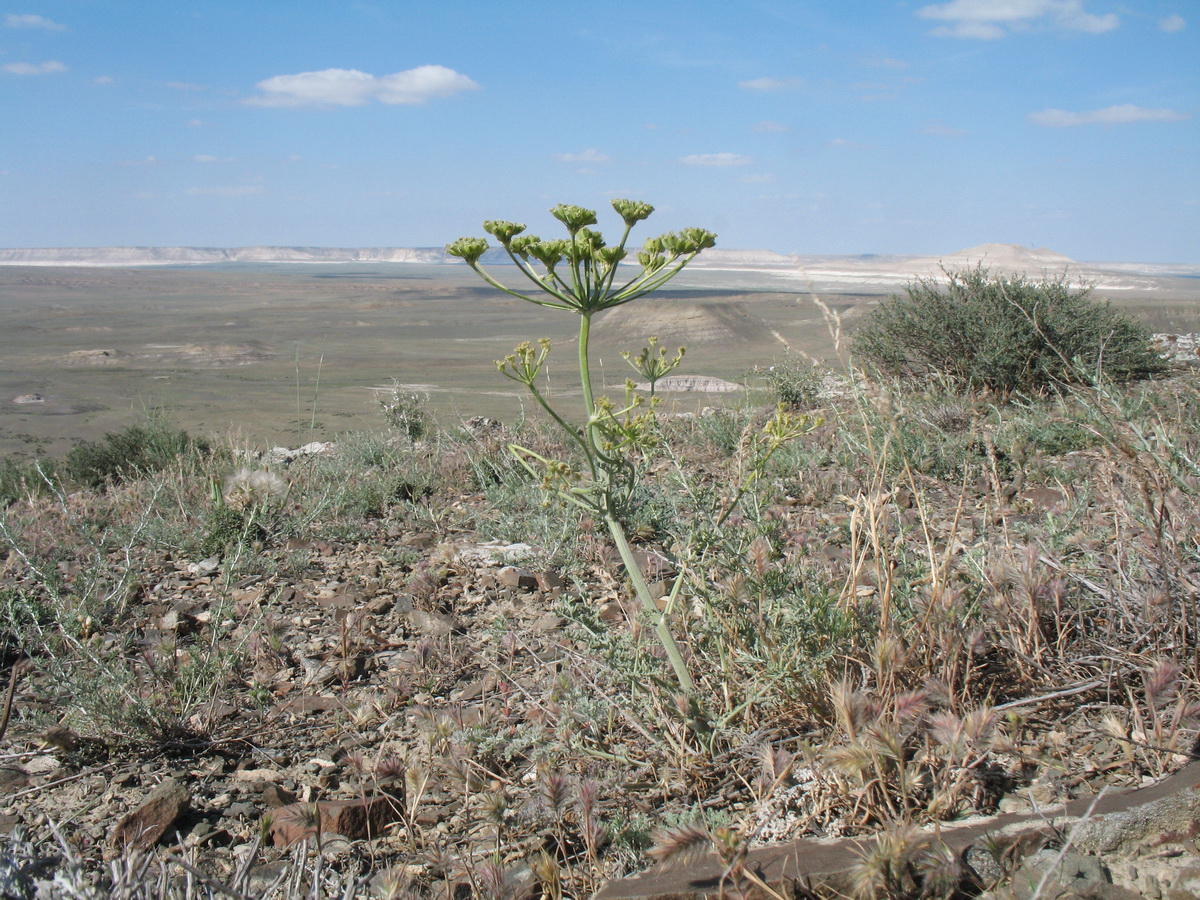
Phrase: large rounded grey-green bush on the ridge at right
[{"left": 851, "top": 266, "right": 1166, "bottom": 394}]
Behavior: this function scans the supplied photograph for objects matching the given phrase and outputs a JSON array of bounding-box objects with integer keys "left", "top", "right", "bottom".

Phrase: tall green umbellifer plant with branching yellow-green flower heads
[{"left": 446, "top": 200, "right": 716, "bottom": 694}]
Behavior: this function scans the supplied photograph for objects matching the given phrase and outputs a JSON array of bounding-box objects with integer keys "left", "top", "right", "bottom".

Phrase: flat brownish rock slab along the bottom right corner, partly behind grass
[{"left": 593, "top": 762, "right": 1200, "bottom": 900}]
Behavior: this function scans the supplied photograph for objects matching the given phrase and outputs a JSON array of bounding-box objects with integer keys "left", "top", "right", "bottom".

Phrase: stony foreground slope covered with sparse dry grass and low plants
[{"left": 0, "top": 256, "right": 1200, "bottom": 900}]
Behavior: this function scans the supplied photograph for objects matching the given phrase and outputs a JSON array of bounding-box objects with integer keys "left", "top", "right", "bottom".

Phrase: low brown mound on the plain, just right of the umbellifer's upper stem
[{"left": 600, "top": 299, "right": 774, "bottom": 346}]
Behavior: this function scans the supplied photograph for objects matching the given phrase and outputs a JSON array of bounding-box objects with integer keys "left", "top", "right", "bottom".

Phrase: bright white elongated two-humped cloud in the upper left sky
[{"left": 246, "top": 66, "right": 479, "bottom": 107}]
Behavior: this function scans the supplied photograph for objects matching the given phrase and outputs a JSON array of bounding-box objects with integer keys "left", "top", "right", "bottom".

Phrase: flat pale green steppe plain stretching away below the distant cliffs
[{"left": 0, "top": 258, "right": 1200, "bottom": 456}]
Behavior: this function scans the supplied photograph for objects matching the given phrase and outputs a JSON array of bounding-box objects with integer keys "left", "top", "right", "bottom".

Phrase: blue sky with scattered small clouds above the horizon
[{"left": 0, "top": 0, "right": 1200, "bottom": 263}]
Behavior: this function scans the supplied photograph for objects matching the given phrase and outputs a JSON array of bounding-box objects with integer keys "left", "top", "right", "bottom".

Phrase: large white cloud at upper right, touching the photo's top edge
[{"left": 917, "top": 0, "right": 1121, "bottom": 41}]
